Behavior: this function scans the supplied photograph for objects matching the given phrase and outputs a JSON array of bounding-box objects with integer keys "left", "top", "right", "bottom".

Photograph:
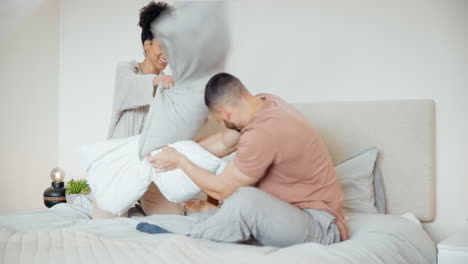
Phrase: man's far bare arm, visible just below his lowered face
[{"left": 197, "top": 128, "right": 240, "bottom": 158}]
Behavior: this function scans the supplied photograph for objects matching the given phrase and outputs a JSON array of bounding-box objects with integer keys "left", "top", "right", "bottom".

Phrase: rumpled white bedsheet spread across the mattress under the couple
[{"left": 0, "top": 204, "right": 436, "bottom": 264}]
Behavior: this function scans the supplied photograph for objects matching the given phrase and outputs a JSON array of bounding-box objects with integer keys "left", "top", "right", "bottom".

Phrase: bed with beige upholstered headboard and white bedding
[{"left": 0, "top": 100, "right": 436, "bottom": 264}]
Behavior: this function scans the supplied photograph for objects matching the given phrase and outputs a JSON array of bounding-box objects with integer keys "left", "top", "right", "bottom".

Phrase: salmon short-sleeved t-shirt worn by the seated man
[{"left": 234, "top": 94, "right": 348, "bottom": 241}]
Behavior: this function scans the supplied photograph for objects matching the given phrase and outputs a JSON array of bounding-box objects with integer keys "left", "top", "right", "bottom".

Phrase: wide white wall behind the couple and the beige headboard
[{"left": 58, "top": 0, "right": 468, "bottom": 241}]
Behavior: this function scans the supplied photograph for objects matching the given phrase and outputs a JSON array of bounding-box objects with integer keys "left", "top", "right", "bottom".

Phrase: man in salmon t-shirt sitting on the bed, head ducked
[{"left": 148, "top": 73, "right": 348, "bottom": 247}]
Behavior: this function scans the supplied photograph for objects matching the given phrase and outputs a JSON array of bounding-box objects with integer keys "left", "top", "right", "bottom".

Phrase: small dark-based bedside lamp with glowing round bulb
[{"left": 44, "top": 167, "right": 67, "bottom": 208}]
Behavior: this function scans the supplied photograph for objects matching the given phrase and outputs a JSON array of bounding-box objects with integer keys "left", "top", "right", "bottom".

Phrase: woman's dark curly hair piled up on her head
[{"left": 138, "top": 1, "right": 172, "bottom": 44}]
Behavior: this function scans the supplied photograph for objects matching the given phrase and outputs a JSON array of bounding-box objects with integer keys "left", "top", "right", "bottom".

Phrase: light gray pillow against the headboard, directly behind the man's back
[{"left": 335, "top": 147, "right": 378, "bottom": 214}]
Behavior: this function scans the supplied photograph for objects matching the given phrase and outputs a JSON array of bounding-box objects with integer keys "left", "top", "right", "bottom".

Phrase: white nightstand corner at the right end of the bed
[{"left": 437, "top": 231, "right": 468, "bottom": 264}]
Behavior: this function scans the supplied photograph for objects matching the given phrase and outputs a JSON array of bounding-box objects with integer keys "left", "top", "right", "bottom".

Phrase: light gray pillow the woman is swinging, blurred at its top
[{"left": 138, "top": 1, "right": 229, "bottom": 158}]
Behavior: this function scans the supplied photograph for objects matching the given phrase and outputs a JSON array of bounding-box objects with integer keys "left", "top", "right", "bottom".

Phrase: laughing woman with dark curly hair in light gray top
[{"left": 93, "top": 2, "right": 184, "bottom": 218}]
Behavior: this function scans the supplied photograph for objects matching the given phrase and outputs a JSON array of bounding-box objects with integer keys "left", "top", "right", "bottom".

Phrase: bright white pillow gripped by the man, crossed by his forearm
[{"left": 81, "top": 136, "right": 226, "bottom": 215}]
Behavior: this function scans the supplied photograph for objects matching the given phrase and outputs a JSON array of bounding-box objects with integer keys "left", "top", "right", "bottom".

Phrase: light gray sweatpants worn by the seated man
[{"left": 190, "top": 187, "right": 340, "bottom": 247}]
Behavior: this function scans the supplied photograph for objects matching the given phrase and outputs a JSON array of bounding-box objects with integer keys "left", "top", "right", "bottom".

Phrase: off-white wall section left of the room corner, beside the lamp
[{"left": 0, "top": 0, "right": 59, "bottom": 214}]
